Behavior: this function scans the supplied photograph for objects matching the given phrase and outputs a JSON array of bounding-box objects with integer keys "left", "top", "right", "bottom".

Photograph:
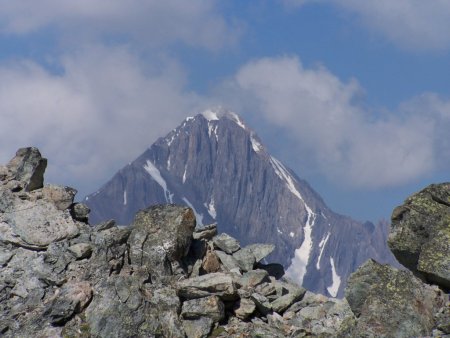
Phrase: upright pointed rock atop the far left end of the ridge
[{"left": 7, "top": 147, "right": 47, "bottom": 191}]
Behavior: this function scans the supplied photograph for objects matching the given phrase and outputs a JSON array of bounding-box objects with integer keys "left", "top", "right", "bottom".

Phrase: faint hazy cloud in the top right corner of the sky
[{"left": 283, "top": 0, "right": 450, "bottom": 50}]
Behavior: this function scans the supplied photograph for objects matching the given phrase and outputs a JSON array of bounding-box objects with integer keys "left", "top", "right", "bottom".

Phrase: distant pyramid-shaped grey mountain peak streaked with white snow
[{"left": 85, "top": 110, "right": 395, "bottom": 297}]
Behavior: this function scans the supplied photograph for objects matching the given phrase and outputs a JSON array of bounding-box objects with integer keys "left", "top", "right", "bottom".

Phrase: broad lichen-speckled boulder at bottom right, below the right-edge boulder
[{"left": 346, "top": 260, "right": 443, "bottom": 337}]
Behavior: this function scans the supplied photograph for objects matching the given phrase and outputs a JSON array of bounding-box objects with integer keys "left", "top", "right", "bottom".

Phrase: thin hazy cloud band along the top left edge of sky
[{"left": 0, "top": 0, "right": 239, "bottom": 50}]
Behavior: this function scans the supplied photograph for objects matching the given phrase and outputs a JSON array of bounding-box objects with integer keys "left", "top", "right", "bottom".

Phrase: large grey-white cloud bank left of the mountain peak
[{"left": 0, "top": 47, "right": 202, "bottom": 197}]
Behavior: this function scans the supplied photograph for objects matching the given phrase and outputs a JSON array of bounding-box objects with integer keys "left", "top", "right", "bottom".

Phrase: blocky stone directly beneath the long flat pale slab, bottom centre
[{"left": 181, "top": 296, "right": 225, "bottom": 323}]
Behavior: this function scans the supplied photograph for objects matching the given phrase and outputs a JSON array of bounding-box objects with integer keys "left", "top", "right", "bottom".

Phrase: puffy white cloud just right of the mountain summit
[{"left": 224, "top": 57, "right": 450, "bottom": 188}]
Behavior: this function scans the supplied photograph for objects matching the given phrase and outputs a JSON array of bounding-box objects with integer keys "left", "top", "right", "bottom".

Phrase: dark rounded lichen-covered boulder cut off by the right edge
[{"left": 388, "top": 183, "right": 450, "bottom": 289}]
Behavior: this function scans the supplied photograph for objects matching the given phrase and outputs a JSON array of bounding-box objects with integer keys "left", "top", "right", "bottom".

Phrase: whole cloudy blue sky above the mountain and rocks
[{"left": 0, "top": 0, "right": 450, "bottom": 221}]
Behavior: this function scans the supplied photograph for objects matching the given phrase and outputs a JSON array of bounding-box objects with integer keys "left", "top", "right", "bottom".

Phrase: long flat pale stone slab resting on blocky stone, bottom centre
[{"left": 177, "top": 272, "right": 237, "bottom": 300}]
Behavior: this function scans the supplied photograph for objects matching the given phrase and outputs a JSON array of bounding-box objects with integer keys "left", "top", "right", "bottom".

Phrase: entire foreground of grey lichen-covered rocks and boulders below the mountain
[{"left": 0, "top": 148, "right": 450, "bottom": 338}]
